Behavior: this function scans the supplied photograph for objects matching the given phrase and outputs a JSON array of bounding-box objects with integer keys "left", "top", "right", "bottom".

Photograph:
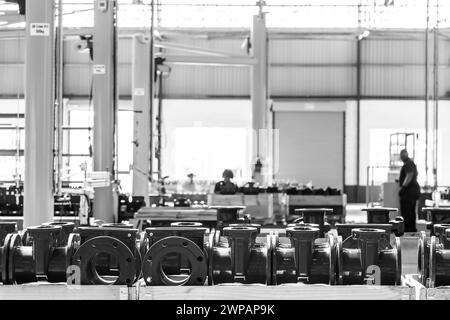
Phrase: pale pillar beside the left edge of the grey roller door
[{"left": 251, "top": 10, "right": 270, "bottom": 182}]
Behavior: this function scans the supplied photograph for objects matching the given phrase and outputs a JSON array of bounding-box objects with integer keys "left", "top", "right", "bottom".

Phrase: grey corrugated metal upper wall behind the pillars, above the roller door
[{"left": 0, "top": 30, "right": 450, "bottom": 98}]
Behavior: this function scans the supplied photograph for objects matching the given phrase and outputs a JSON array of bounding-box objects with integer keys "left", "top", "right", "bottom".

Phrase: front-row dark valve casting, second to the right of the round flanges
[{"left": 272, "top": 225, "right": 336, "bottom": 285}]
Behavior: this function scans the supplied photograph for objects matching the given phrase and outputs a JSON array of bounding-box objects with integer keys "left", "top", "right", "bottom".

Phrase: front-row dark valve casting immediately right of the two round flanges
[{"left": 209, "top": 227, "right": 271, "bottom": 284}]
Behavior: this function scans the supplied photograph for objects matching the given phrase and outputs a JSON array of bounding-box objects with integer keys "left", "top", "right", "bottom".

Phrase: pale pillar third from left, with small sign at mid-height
[{"left": 132, "top": 34, "right": 151, "bottom": 200}]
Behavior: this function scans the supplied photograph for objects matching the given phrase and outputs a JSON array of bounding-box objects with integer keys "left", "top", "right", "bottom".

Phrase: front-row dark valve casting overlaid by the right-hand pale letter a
[{"left": 338, "top": 228, "right": 401, "bottom": 285}]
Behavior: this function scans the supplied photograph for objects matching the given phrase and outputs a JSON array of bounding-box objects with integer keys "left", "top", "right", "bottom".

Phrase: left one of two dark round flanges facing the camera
[{"left": 72, "top": 236, "right": 136, "bottom": 285}]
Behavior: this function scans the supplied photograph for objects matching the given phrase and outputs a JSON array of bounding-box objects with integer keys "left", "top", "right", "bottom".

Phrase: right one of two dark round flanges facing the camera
[{"left": 142, "top": 236, "right": 207, "bottom": 286}]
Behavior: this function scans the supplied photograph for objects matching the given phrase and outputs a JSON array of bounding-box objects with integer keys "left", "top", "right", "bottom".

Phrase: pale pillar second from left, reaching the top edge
[{"left": 92, "top": 0, "right": 116, "bottom": 222}]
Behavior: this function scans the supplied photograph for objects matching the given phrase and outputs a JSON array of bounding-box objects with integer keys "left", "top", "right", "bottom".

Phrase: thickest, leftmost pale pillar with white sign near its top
[{"left": 23, "top": 0, "right": 55, "bottom": 227}]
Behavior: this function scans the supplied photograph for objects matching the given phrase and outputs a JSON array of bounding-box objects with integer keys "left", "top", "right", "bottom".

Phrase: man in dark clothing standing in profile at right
[{"left": 398, "top": 150, "right": 420, "bottom": 232}]
